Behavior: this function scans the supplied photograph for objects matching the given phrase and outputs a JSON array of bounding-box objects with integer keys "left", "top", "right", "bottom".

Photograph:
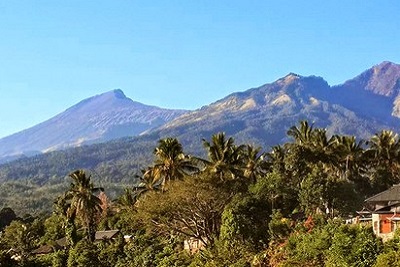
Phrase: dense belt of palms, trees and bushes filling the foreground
[{"left": 0, "top": 121, "right": 400, "bottom": 267}]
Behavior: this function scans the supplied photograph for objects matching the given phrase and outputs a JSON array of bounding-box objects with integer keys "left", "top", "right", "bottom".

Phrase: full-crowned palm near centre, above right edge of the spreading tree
[{"left": 203, "top": 133, "right": 244, "bottom": 180}]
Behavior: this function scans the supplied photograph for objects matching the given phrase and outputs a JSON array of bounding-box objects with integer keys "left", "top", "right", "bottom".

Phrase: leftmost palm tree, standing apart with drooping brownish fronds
[{"left": 65, "top": 170, "right": 104, "bottom": 242}]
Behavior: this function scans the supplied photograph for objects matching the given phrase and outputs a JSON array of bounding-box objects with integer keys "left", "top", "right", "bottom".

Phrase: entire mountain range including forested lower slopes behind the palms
[{"left": 0, "top": 62, "right": 400, "bottom": 216}]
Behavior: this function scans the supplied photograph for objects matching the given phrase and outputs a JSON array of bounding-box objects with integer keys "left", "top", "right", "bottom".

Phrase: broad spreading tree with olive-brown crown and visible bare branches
[{"left": 138, "top": 177, "right": 231, "bottom": 248}]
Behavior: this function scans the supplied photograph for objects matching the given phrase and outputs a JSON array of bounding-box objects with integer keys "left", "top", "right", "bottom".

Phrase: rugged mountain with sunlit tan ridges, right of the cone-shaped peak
[{"left": 155, "top": 62, "right": 400, "bottom": 152}]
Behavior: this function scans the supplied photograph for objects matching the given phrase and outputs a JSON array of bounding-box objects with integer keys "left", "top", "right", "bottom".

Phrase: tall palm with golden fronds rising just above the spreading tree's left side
[{"left": 152, "top": 138, "right": 199, "bottom": 190}]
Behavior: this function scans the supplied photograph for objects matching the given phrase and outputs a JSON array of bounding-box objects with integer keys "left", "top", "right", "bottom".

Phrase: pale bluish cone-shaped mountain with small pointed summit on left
[{"left": 0, "top": 89, "right": 186, "bottom": 159}]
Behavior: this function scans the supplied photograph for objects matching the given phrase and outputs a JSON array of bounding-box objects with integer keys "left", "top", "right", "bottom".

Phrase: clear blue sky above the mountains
[{"left": 0, "top": 0, "right": 400, "bottom": 137}]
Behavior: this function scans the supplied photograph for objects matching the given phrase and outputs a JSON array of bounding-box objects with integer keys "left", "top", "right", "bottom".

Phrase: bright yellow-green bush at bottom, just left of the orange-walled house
[{"left": 283, "top": 221, "right": 382, "bottom": 266}]
